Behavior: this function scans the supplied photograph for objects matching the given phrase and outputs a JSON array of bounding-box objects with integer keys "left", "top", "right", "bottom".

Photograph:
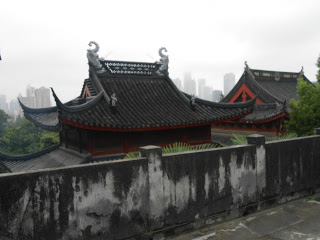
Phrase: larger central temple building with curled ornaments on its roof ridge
[{"left": 0, "top": 42, "right": 256, "bottom": 171}]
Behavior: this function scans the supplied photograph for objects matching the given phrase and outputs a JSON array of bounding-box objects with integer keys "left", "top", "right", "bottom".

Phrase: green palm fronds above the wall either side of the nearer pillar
[{"left": 124, "top": 142, "right": 221, "bottom": 159}]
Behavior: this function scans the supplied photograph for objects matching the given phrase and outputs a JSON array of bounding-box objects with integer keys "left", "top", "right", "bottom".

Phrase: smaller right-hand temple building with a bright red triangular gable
[{"left": 213, "top": 63, "right": 312, "bottom": 135}]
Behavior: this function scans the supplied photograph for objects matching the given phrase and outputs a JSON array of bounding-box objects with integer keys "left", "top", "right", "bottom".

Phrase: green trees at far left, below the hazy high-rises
[{"left": 0, "top": 120, "right": 59, "bottom": 154}]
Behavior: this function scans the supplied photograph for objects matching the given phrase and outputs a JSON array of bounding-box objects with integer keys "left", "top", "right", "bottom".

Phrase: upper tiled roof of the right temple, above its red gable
[{"left": 221, "top": 66, "right": 311, "bottom": 107}]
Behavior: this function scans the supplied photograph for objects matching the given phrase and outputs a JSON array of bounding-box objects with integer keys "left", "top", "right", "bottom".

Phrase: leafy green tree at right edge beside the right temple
[{"left": 285, "top": 79, "right": 320, "bottom": 136}]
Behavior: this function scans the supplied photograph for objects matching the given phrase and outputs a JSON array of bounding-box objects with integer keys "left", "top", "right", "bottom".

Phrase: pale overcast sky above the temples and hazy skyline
[{"left": 0, "top": 0, "right": 320, "bottom": 101}]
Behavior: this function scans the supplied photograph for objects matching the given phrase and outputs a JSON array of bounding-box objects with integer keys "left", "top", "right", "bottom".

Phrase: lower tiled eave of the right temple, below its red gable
[{"left": 238, "top": 103, "right": 289, "bottom": 122}]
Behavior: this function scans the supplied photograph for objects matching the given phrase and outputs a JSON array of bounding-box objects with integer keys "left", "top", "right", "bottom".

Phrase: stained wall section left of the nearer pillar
[{"left": 0, "top": 159, "right": 149, "bottom": 239}]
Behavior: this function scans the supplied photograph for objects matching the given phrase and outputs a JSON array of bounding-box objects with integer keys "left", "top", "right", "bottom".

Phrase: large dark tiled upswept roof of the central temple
[{"left": 53, "top": 61, "right": 255, "bottom": 130}]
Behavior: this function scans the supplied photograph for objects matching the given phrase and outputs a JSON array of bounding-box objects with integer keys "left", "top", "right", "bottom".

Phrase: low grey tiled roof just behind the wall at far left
[{"left": 0, "top": 145, "right": 88, "bottom": 172}]
